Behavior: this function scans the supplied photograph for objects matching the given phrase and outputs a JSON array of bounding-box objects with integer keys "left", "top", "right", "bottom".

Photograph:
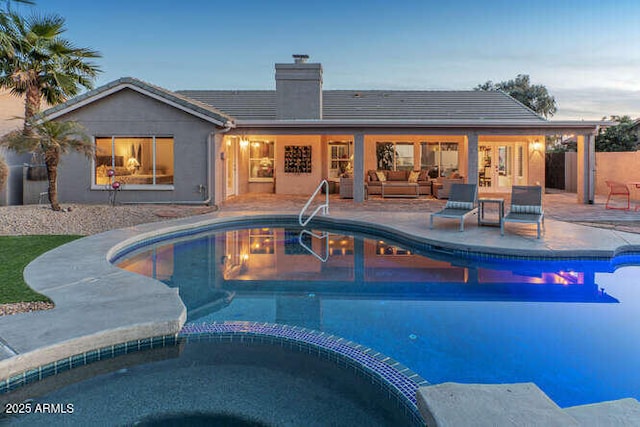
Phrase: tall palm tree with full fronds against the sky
[{"left": 0, "top": 13, "right": 101, "bottom": 134}]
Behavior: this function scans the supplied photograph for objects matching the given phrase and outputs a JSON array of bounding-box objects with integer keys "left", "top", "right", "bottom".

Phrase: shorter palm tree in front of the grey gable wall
[{"left": 0, "top": 120, "right": 95, "bottom": 211}]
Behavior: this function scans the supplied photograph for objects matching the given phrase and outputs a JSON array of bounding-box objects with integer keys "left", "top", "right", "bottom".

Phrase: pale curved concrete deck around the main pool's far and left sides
[{"left": 0, "top": 191, "right": 640, "bottom": 424}]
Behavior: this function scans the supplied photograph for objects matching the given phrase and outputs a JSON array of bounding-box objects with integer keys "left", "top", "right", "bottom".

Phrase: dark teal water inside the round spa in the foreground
[{"left": 0, "top": 340, "right": 415, "bottom": 427}]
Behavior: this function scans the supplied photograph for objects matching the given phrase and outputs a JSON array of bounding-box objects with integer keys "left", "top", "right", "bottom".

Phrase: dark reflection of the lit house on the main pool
[{"left": 118, "top": 227, "right": 618, "bottom": 318}]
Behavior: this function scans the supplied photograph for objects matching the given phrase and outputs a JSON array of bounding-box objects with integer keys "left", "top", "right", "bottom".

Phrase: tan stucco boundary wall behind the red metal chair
[{"left": 596, "top": 151, "right": 640, "bottom": 196}]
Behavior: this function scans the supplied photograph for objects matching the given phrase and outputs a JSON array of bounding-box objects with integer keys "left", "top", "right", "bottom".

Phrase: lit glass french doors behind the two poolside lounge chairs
[{"left": 478, "top": 142, "right": 526, "bottom": 192}]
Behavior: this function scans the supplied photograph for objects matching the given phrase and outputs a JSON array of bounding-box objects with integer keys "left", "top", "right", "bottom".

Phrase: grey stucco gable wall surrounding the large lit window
[{"left": 58, "top": 89, "right": 215, "bottom": 203}]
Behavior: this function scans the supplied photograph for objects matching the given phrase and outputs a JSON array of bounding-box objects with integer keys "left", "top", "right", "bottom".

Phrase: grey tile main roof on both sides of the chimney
[{"left": 177, "top": 90, "right": 546, "bottom": 122}]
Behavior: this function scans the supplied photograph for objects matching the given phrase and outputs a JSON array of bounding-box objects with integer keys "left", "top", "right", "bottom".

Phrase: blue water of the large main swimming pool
[{"left": 117, "top": 226, "right": 640, "bottom": 407}]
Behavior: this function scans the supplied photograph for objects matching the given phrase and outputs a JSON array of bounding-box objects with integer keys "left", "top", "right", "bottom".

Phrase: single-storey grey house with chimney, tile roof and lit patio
[{"left": 37, "top": 55, "right": 600, "bottom": 203}]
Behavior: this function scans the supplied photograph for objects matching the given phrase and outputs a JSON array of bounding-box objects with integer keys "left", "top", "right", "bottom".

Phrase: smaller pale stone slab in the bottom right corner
[{"left": 564, "top": 399, "right": 640, "bottom": 427}]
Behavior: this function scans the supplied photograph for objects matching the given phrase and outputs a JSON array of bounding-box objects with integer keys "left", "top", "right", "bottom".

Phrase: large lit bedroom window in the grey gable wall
[{"left": 94, "top": 136, "right": 174, "bottom": 188}]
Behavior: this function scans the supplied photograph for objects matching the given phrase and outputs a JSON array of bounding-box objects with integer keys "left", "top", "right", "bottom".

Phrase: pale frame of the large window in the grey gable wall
[{"left": 91, "top": 134, "right": 176, "bottom": 191}]
